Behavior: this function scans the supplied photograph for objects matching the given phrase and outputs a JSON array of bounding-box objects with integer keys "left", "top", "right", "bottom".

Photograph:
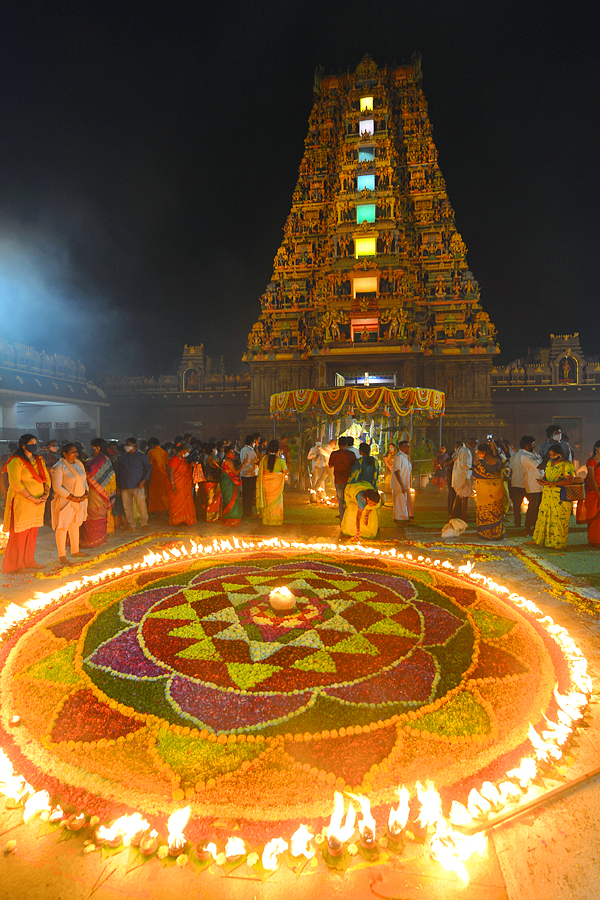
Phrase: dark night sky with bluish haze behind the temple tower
[{"left": 0, "top": 0, "right": 600, "bottom": 375}]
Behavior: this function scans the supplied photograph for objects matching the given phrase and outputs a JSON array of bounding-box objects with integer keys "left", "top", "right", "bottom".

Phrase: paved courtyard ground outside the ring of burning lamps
[{"left": 0, "top": 489, "right": 600, "bottom": 900}]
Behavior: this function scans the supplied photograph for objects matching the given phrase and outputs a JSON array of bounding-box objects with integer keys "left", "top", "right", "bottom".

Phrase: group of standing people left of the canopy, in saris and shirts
[{"left": 0, "top": 434, "right": 289, "bottom": 573}]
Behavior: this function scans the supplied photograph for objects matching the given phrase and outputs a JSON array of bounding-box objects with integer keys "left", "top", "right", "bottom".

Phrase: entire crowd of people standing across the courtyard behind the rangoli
[{"left": 0, "top": 425, "right": 600, "bottom": 573}]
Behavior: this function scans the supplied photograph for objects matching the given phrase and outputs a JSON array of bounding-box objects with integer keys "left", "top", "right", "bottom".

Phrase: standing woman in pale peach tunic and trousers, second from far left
[{"left": 51, "top": 444, "right": 88, "bottom": 566}]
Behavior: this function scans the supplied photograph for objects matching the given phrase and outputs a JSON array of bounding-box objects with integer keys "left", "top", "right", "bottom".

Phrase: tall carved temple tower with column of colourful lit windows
[{"left": 244, "top": 56, "right": 498, "bottom": 436}]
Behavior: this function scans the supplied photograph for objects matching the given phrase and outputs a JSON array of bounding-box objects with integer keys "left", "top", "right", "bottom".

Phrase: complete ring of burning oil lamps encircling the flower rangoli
[{"left": 0, "top": 538, "right": 592, "bottom": 881}]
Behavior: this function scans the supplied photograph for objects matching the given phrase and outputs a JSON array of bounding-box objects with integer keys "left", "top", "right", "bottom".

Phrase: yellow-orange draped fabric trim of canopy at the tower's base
[{"left": 271, "top": 387, "right": 446, "bottom": 419}]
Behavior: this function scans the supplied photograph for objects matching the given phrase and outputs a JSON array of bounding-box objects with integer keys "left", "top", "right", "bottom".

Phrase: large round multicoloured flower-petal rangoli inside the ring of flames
[{"left": 0, "top": 550, "right": 568, "bottom": 836}]
